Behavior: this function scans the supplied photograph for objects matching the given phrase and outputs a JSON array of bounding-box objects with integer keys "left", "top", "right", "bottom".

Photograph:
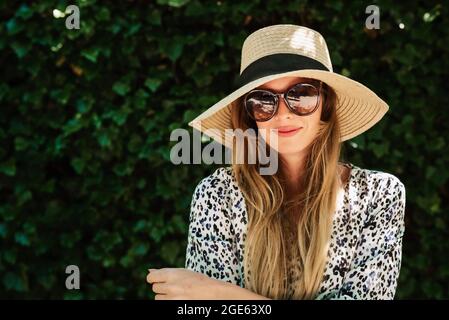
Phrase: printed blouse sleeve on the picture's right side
[{"left": 317, "top": 175, "right": 406, "bottom": 300}]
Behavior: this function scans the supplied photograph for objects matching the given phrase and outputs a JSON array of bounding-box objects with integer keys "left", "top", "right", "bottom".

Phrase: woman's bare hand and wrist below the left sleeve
[{"left": 147, "top": 268, "right": 228, "bottom": 300}]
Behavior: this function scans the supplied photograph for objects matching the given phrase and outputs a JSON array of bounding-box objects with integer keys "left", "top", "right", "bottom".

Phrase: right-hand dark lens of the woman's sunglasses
[{"left": 287, "top": 83, "right": 318, "bottom": 114}]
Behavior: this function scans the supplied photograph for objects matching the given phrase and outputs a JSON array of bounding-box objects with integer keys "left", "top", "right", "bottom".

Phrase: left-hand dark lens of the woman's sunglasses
[{"left": 245, "top": 91, "right": 276, "bottom": 121}]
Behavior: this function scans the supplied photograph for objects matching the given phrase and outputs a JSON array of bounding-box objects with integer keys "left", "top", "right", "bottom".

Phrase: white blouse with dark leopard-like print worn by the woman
[{"left": 185, "top": 163, "right": 406, "bottom": 299}]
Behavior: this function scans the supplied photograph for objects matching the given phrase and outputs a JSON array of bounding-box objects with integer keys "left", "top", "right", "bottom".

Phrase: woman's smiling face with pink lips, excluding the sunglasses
[{"left": 252, "top": 77, "right": 322, "bottom": 155}]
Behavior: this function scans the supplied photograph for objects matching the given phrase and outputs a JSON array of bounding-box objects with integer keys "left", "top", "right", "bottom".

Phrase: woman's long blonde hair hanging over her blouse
[{"left": 231, "top": 83, "right": 342, "bottom": 300}]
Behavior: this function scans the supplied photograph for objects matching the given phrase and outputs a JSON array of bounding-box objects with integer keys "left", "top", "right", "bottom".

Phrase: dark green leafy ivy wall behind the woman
[{"left": 0, "top": 0, "right": 449, "bottom": 299}]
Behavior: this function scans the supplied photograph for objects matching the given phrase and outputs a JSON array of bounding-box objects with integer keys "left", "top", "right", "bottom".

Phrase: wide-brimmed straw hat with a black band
[{"left": 189, "top": 24, "right": 388, "bottom": 147}]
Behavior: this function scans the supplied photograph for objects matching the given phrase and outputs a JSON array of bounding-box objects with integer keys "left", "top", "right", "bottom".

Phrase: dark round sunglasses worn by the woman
[{"left": 243, "top": 81, "right": 322, "bottom": 122}]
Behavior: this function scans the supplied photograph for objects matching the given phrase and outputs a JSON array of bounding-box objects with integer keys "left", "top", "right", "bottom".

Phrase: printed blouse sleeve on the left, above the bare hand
[{"left": 185, "top": 168, "right": 241, "bottom": 285}]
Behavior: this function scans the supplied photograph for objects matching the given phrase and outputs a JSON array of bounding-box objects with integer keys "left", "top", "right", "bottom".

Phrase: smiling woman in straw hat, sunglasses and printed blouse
[{"left": 147, "top": 25, "right": 405, "bottom": 299}]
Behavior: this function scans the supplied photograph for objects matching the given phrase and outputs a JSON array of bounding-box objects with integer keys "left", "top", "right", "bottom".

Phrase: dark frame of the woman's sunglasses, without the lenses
[{"left": 243, "top": 80, "right": 323, "bottom": 122}]
